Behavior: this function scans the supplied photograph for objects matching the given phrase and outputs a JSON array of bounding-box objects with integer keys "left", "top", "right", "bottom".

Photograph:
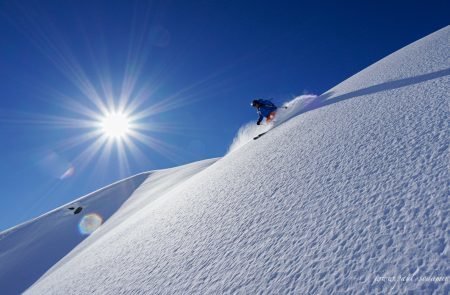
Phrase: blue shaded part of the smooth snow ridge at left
[{"left": 0, "top": 173, "right": 148, "bottom": 294}]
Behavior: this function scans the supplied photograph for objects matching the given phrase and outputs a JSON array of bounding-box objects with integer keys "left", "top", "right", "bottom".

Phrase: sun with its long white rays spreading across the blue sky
[{"left": 0, "top": 4, "right": 237, "bottom": 184}]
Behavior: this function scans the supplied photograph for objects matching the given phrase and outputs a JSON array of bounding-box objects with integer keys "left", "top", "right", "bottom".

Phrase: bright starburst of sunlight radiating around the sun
[{"left": 2, "top": 8, "right": 227, "bottom": 182}]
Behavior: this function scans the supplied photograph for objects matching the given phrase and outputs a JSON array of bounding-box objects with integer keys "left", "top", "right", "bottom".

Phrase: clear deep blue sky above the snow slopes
[{"left": 0, "top": 0, "right": 450, "bottom": 230}]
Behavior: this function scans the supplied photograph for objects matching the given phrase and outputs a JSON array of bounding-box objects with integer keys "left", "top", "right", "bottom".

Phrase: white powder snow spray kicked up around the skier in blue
[{"left": 228, "top": 94, "right": 318, "bottom": 153}]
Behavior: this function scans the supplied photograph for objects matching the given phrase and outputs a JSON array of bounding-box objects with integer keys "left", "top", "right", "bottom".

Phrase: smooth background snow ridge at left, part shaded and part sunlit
[{"left": 0, "top": 159, "right": 216, "bottom": 294}]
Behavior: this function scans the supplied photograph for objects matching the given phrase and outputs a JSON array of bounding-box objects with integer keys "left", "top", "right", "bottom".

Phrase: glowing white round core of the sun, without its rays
[{"left": 100, "top": 112, "right": 130, "bottom": 139}]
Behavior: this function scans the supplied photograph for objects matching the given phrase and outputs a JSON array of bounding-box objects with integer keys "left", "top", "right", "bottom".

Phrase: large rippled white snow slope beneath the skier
[{"left": 0, "top": 27, "right": 450, "bottom": 294}]
